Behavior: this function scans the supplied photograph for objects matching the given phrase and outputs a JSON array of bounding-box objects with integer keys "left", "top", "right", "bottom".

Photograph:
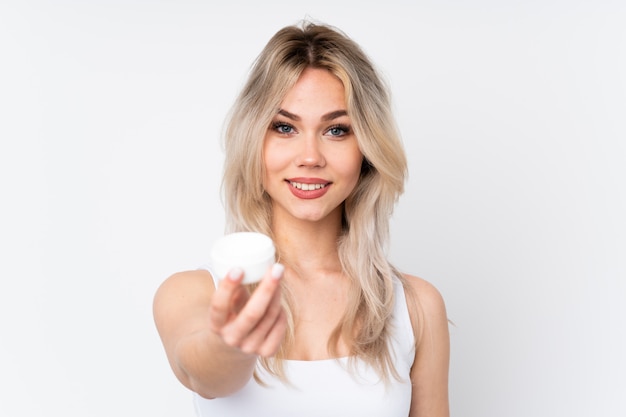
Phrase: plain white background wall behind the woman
[{"left": 0, "top": 0, "right": 626, "bottom": 417}]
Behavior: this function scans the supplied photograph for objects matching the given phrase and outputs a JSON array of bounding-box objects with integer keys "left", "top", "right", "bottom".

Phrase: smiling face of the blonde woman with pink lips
[{"left": 263, "top": 68, "right": 363, "bottom": 221}]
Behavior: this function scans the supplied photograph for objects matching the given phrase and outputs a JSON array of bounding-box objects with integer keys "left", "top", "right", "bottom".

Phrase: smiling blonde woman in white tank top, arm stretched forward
[{"left": 154, "top": 22, "right": 449, "bottom": 417}]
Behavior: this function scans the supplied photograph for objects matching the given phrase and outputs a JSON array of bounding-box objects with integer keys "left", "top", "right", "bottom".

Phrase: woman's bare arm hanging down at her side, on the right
[{"left": 406, "top": 276, "right": 450, "bottom": 417}]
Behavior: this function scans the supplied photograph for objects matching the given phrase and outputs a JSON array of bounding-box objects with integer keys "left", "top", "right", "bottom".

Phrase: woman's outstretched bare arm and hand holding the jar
[{"left": 153, "top": 266, "right": 286, "bottom": 398}]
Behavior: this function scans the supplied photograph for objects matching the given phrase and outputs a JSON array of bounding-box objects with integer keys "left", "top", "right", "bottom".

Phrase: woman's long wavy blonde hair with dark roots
[{"left": 222, "top": 22, "right": 407, "bottom": 380}]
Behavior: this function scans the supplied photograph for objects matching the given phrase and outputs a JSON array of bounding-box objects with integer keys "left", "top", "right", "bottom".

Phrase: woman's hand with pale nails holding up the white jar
[{"left": 209, "top": 264, "right": 287, "bottom": 356}]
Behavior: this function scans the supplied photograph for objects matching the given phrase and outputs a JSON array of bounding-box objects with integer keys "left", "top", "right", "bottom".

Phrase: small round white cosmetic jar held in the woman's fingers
[{"left": 211, "top": 232, "right": 276, "bottom": 284}]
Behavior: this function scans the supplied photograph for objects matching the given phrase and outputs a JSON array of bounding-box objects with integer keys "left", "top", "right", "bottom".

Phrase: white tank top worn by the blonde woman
[{"left": 193, "top": 267, "right": 415, "bottom": 417}]
